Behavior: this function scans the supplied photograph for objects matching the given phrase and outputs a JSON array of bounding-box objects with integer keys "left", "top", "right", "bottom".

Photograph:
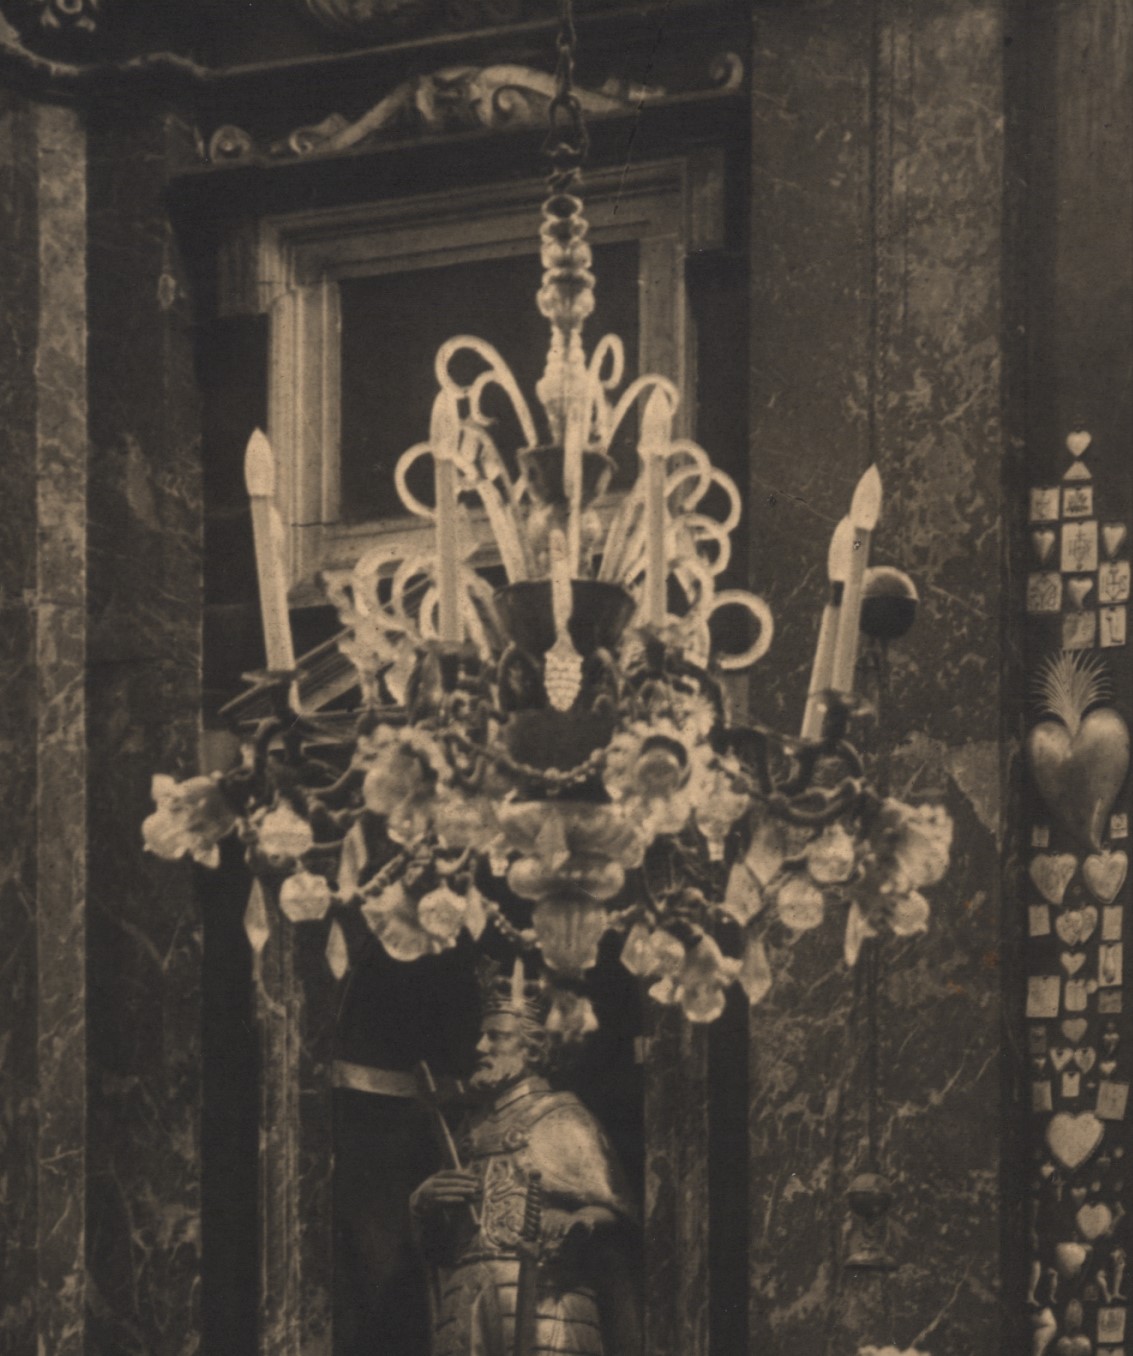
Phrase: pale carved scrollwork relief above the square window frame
[{"left": 209, "top": 53, "right": 744, "bottom": 164}]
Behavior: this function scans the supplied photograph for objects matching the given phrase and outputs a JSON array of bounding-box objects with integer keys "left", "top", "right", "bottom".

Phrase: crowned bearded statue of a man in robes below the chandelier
[{"left": 412, "top": 972, "right": 641, "bottom": 1356}]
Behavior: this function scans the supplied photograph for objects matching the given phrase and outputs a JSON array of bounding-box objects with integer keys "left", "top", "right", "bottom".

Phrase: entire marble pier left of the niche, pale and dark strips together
[{"left": 0, "top": 95, "right": 201, "bottom": 1356}]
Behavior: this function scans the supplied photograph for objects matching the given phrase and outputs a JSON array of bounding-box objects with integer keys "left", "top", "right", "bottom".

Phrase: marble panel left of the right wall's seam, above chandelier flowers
[{"left": 749, "top": 0, "right": 870, "bottom": 727}]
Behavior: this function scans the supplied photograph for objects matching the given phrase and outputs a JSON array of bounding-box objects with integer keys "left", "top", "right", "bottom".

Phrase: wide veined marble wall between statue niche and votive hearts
[{"left": 751, "top": 0, "right": 1004, "bottom": 1356}]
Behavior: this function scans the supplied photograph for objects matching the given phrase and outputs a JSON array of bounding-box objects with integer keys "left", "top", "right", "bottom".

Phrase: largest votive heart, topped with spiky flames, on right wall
[{"left": 1026, "top": 650, "right": 1129, "bottom": 850}]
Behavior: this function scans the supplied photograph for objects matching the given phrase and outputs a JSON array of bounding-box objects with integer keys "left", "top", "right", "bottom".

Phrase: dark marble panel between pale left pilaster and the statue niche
[{"left": 87, "top": 108, "right": 202, "bottom": 1356}]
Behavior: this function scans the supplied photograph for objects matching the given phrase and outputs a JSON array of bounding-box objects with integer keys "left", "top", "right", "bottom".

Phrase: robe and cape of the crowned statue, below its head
[{"left": 421, "top": 1078, "right": 638, "bottom": 1356}]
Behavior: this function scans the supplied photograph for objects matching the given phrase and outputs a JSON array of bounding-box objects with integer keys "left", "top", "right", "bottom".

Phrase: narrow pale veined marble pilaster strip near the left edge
[{"left": 34, "top": 107, "right": 87, "bottom": 1356}]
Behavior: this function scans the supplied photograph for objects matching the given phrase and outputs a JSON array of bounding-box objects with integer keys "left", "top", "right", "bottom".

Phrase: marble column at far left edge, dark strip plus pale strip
[{"left": 0, "top": 99, "right": 87, "bottom": 1356}]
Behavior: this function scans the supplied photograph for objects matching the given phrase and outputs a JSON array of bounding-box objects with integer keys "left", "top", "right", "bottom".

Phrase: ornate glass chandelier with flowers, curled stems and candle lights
[{"left": 144, "top": 2, "right": 951, "bottom": 1039}]
